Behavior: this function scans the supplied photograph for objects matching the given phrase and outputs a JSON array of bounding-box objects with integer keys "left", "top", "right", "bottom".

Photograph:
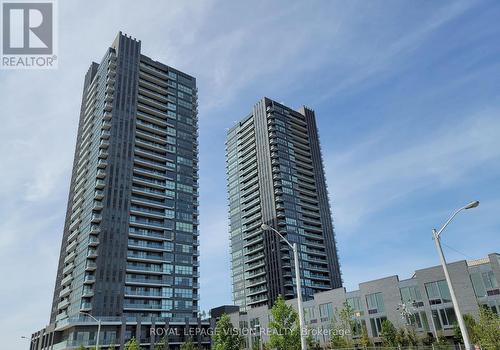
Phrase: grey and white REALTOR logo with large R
[{"left": 1, "top": 0, "right": 57, "bottom": 69}]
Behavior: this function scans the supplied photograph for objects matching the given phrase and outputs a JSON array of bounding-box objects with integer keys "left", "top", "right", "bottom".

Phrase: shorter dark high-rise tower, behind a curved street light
[{"left": 226, "top": 98, "right": 342, "bottom": 310}]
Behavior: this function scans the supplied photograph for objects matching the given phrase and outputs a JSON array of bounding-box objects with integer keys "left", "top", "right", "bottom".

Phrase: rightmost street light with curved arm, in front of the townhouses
[{"left": 432, "top": 201, "right": 479, "bottom": 350}]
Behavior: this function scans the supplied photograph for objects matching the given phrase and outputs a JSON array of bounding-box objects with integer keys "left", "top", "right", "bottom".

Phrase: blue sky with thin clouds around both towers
[{"left": 0, "top": 0, "right": 500, "bottom": 350}]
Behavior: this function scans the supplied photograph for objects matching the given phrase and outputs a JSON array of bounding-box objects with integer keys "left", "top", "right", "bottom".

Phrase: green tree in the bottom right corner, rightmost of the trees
[{"left": 473, "top": 306, "right": 500, "bottom": 350}]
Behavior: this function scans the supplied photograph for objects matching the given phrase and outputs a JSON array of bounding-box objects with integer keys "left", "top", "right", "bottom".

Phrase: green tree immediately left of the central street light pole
[{"left": 269, "top": 295, "right": 300, "bottom": 350}]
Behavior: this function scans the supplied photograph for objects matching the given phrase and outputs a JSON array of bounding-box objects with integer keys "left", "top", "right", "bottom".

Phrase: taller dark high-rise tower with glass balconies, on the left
[{"left": 31, "top": 33, "right": 204, "bottom": 345}]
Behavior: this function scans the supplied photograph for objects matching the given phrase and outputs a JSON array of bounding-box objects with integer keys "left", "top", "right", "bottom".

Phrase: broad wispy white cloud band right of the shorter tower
[{"left": 326, "top": 110, "right": 500, "bottom": 235}]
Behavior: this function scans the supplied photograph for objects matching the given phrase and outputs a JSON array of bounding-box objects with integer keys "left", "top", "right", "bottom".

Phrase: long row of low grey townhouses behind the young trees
[{"left": 229, "top": 253, "right": 500, "bottom": 346}]
